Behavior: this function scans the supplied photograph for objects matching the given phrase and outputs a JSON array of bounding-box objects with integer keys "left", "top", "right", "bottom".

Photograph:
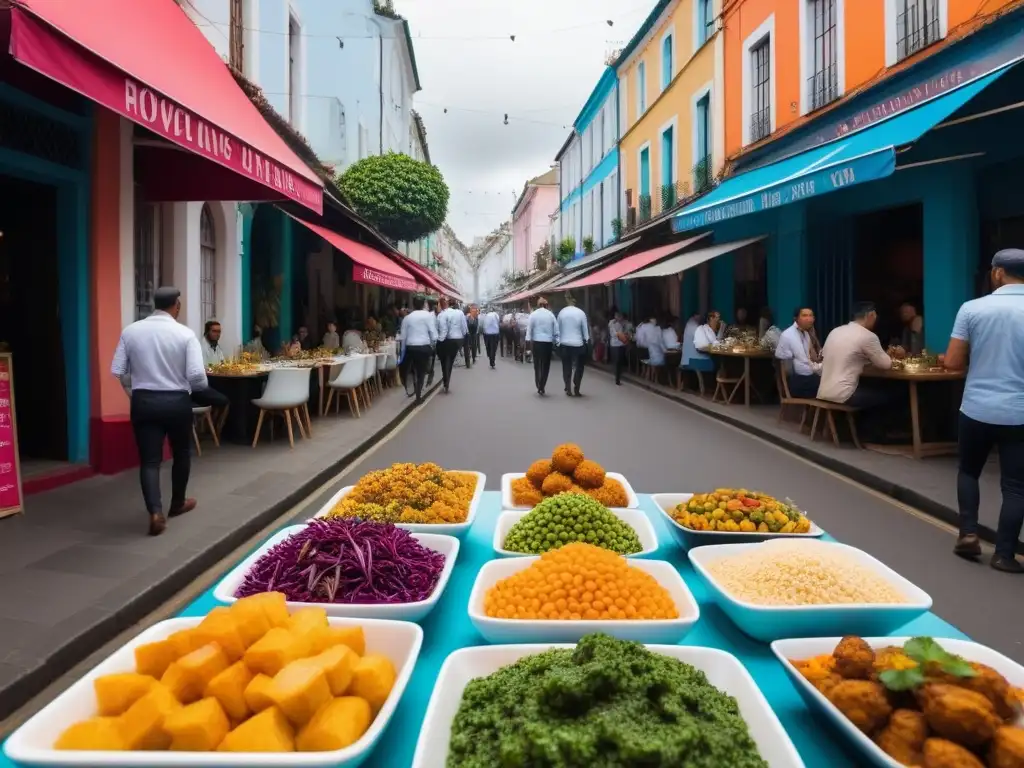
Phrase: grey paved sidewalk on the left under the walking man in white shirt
[{"left": 0, "top": 388, "right": 436, "bottom": 720}]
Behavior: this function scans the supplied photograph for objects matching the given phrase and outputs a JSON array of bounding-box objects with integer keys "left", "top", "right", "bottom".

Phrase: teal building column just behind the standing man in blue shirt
[{"left": 919, "top": 168, "right": 979, "bottom": 352}]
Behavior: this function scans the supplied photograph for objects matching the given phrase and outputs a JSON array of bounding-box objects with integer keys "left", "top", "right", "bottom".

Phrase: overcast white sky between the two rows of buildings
[{"left": 394, "top": 0, "right": 654, "bottom": 245}]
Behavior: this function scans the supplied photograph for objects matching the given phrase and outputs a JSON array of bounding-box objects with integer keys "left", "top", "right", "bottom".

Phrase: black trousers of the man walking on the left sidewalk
[{"left": 131, "top": 389, "right": 193, "bottom": 514}]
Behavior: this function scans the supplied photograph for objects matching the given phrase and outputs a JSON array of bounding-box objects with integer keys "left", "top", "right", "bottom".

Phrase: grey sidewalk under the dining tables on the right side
[{"left": 592, "top": 364, "right": 1007, "bottom": 552}]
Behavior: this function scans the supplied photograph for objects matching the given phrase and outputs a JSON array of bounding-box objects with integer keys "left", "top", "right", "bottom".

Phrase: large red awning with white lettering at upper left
[{"left": 10, "top": 0, "right": 324, "bottom": 213}]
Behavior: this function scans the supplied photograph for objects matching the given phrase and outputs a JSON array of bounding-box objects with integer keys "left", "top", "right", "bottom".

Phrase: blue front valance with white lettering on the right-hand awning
[{"left": 672, "top": 147, "right": 896, "bottom": 232}]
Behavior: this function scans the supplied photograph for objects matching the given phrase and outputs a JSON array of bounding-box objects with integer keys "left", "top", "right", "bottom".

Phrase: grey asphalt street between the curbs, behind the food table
[{"left": 344, "top": 358, "right": 1024, "bottom": 660}]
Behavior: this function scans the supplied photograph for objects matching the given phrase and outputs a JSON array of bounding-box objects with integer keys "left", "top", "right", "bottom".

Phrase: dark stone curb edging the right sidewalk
[{"left": 590, "top": 364, "right": 1011, "bottom": 554}]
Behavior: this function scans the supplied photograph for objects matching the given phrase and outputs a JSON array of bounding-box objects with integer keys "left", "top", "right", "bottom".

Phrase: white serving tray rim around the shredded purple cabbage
[{"left": 213, "top": 524, "right": 459, "bottom": 622}]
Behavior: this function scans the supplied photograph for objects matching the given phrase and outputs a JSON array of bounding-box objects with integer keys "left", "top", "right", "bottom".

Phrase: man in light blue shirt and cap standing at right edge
[{"left": 943, "top": 248, "right": 1024, "bottom": 573}]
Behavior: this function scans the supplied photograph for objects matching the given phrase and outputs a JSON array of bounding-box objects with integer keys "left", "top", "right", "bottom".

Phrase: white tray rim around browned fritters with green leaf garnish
[{"left": 771, "top": 637, "right": 1024, "bottom": 768}]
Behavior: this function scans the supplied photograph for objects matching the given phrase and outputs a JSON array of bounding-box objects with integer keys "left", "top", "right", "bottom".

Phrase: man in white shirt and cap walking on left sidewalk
[{"left": 111, "top": 287, "right": 207, "bottom": 536}]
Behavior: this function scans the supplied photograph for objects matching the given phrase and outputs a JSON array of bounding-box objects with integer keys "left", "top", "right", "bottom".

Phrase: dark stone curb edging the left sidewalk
[{"left": 0, "top": 381, "right": 440, "bottom": 721}]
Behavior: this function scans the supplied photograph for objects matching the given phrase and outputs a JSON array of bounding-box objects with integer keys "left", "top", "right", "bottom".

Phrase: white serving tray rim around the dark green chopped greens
[{"left": 413, "top": 644, "right": 804, "bottom": 768}]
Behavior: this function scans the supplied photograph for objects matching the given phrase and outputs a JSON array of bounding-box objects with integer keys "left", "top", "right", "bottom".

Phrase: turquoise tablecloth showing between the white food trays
[{"left": 0, "top": 492, "right": 965, "bottom": 768}]
